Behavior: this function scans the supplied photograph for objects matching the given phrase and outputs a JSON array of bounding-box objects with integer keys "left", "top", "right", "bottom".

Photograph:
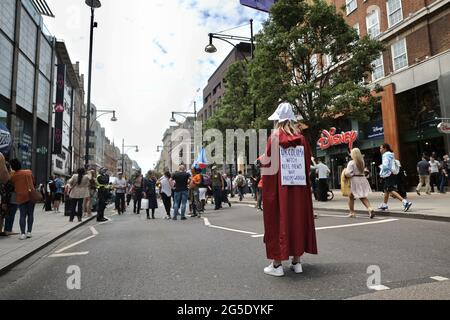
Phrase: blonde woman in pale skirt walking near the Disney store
[{"left": 345, "top": 148, "right": 375, "bottom": 219}]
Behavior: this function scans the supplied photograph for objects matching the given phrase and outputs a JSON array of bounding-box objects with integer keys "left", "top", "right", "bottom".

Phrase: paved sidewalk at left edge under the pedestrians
[{"left": 0, "top": 205, "right": 96, "bottom": 276}]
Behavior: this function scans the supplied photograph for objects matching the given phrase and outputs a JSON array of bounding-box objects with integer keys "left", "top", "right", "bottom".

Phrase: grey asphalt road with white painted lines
[{"left": 0, "top": 205, "right": 450, "bottom": 300}]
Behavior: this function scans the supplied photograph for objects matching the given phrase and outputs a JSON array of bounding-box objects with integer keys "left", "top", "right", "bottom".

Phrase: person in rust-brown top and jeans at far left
[{"left": 10, "top": 159, "right": 34, "bottom": 240}]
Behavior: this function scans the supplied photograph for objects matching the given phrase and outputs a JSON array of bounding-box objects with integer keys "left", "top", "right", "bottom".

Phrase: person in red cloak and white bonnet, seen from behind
[{"left": 262, "top": 103, "right": 318, "bottom": 277}]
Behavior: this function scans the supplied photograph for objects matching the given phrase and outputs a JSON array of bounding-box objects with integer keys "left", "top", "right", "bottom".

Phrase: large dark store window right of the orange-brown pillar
[{"left": 396, "top": 81, "right": 441, "bottom": 132}]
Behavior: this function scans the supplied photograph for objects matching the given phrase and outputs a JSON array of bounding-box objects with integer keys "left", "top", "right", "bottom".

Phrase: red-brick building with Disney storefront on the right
[{"left": 321, "top": 0, "right": 450, "bottom": 185}]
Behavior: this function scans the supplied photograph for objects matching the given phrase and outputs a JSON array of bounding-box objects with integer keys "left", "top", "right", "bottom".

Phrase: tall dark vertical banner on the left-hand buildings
[{"left": 53, "top": 64, "right": 66, "bottom": 154}]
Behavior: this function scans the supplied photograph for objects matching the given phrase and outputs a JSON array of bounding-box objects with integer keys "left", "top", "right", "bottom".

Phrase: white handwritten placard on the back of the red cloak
[{"left": 280, "top": 146, "right": 307, "bottom": 186}]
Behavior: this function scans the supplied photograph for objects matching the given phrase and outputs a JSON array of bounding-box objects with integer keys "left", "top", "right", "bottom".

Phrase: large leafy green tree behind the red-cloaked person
[{"left": 248, "top": 0, "right": 383, "bottom": 149}]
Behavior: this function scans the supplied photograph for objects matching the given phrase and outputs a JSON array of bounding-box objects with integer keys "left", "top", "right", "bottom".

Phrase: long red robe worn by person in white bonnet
[{"left": 263, "top": 130, "right": 318, "bottom": 261}]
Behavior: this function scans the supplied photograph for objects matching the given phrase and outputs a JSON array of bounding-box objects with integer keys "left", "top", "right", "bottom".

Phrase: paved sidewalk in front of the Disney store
[{"left": 230, "top": 190, "right": 450, "bottom": 222}]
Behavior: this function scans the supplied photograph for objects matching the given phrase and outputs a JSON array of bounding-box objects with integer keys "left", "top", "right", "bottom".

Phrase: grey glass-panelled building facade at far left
[{"left": 0, "top": 0, "right": 55, "bottom": 183}]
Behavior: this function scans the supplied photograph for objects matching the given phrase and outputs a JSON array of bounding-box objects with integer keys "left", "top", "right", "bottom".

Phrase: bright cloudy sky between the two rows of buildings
[{"left": 45, "top": 0, "right": 268, "bottom": 171}]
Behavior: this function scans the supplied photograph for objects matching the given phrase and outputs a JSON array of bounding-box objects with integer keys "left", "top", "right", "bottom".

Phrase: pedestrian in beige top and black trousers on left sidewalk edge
[{"left": 68, "top": 168, "right": 90, "bottom": 222}]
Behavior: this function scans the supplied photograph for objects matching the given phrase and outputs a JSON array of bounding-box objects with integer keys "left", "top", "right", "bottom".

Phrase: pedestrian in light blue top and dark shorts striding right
[{"left": 378, "top": 143, "right": 412, "bottom": 212}]
